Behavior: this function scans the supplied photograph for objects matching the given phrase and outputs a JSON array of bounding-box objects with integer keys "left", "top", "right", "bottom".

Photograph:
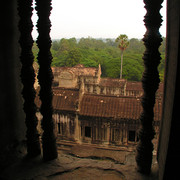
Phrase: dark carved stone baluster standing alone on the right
[{"left": 136, "top": 0, "right": 163, "bottom": 174}]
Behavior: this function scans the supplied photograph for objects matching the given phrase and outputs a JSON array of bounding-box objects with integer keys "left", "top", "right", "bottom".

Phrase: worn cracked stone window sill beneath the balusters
[{"left": 0, "top": 143, "right": 158, "bottom": 180}]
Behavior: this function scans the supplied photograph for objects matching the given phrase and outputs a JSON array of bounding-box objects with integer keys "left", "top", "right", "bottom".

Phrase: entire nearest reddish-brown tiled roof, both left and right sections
[{"left": 35, "top": 87, "right": 162, "bottom": 120}]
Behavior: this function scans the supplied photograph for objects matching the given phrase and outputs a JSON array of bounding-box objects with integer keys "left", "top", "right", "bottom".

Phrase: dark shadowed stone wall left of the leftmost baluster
[{"left": 0, "top": 0, "right": 26, "bottom": 170}]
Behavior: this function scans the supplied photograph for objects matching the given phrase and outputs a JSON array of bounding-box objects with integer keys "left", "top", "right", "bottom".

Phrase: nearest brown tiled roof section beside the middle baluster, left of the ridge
[{"left": 35, "top": 88, "right": 79, "bottom": 111}]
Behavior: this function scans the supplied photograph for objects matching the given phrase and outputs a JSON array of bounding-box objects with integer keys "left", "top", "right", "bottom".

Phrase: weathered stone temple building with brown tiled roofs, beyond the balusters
[{"left": 36, "top": 64, "right": 163, "bottom": 145}]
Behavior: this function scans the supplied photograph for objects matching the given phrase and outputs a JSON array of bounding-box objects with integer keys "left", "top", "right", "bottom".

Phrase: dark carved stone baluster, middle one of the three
[{"left": 36, "top": 0, "right": 57, "bottom": 160}]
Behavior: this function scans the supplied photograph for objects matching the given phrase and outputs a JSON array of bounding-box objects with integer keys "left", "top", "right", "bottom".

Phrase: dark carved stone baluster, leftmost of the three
[{"left": 18, "top": 0, "right": 41, "bottom": 157}]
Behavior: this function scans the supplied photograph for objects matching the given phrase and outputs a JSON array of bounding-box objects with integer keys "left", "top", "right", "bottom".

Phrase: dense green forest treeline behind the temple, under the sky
[{"left": 33, "top": 37, "right": 165, "bottom": 81}]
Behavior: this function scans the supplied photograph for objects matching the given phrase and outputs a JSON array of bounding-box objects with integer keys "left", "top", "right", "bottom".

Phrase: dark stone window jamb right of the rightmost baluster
[{"left": 158, "top": 0, "right": 180, "bottom": 180}]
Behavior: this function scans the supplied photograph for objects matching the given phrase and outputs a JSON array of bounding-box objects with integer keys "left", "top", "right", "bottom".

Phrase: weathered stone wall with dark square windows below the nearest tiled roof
[{"left": 51, "top": 112, "right": 143, "bottom": 145}]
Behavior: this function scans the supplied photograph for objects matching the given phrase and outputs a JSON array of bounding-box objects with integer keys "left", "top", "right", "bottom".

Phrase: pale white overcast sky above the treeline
[{"left": 32, "top": 0, "right": 166, "bottom": 39}]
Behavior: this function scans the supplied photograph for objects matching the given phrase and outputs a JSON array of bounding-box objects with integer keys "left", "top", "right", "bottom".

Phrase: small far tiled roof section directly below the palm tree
[{"left": 99, "top": 78, "right": 127, "bottom": 88}]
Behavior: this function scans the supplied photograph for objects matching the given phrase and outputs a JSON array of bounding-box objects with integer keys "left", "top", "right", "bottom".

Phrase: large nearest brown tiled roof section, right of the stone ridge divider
[{"left": 80, "top": 94, "right": 142, "bottom": 119}]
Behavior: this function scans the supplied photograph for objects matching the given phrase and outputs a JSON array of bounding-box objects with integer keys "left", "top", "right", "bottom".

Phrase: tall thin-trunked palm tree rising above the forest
[{"left": 116, "top": 34, "right": 129, "bottom": 79}]
